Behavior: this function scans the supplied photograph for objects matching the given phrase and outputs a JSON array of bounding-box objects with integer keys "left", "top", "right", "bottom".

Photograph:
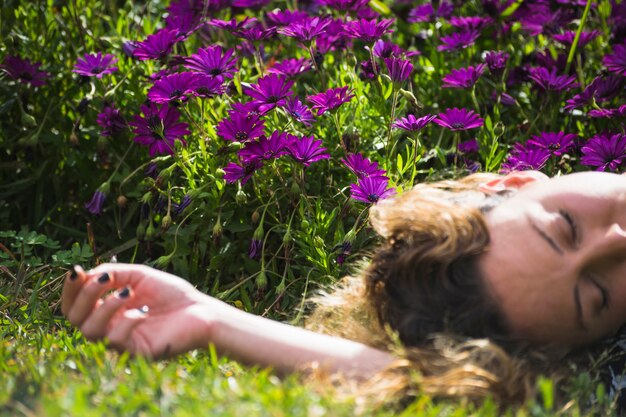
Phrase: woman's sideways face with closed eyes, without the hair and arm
[{"left": 479, "top": 172, "right": 626, "bottom": 346}]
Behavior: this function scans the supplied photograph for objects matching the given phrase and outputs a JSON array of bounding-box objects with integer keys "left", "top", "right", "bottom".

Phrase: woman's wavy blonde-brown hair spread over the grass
[{"left": 307, "top": 174, "right": 563, "bottom": 404}]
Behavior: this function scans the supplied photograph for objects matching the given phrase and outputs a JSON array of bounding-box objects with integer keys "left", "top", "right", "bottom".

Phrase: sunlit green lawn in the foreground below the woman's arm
[{"left": 0, "top": 268, "right": 615, "bottom": 417}]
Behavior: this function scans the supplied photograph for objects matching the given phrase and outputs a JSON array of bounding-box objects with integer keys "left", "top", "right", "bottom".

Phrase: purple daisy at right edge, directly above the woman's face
[{"left": 580, "top": 133, "right": 626, "bottom": 171}]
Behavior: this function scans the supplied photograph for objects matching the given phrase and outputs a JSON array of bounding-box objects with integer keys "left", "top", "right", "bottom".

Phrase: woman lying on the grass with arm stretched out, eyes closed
[{"left": 62, "top": 171, "right": 626, "bottom": 402}]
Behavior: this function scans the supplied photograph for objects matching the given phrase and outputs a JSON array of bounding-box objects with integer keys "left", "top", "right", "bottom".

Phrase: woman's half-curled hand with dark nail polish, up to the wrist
[{"left": 61, "top": 264, "right": 214, "bottom": 358}]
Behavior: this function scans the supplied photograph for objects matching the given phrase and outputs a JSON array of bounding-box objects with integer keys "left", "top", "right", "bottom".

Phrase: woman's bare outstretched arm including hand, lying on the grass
[{"left": 62, "top": 264, "right": 393, "bottom": 378}]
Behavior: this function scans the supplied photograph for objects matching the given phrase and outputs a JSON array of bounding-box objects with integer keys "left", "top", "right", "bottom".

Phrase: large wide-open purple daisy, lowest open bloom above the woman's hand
[{"left": 128, "top": 103, "right": 191, "bottom": 156}]
